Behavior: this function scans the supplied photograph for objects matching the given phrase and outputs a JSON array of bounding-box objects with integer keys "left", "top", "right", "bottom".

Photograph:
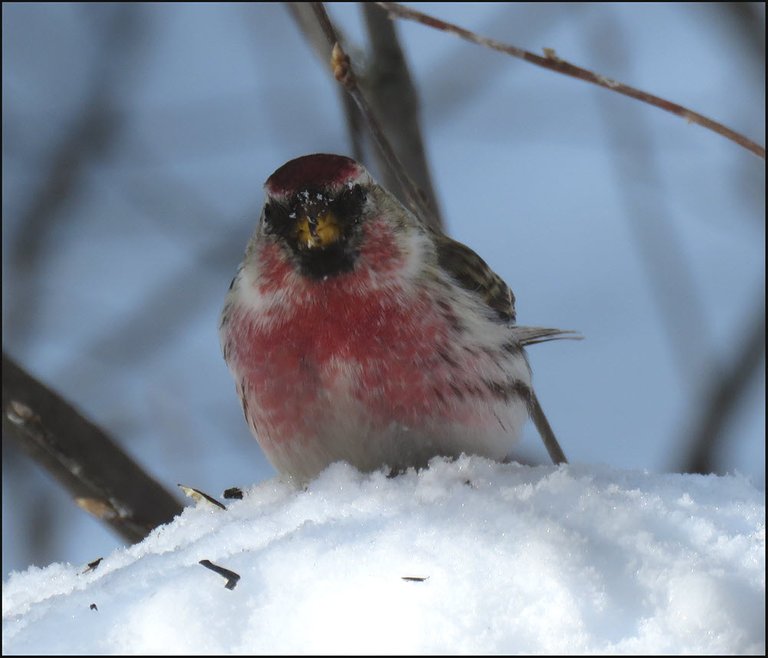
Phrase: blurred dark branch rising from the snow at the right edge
[{"left": 681, "top": 300, "right": 765, "bottom": 473}]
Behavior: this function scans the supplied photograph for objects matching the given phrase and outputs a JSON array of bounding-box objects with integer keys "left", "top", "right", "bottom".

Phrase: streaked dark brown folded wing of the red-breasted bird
[{"left": 435, "top": 233, "right": 515, "bottom": 324}]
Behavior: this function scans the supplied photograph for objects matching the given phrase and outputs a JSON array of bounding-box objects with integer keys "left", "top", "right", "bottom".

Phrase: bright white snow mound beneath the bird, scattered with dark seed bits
[{"left": 3, "top": 458, "right": 765, "bottom": 654}]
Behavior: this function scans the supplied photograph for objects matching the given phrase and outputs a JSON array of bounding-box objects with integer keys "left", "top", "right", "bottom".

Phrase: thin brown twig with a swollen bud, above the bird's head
[{"left": 312, "top": 2, "right": 436, "bottom": 226}]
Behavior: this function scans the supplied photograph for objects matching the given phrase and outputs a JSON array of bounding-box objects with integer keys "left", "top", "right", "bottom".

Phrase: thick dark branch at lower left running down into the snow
[{"left": 3, "top": 353, "right": 182, "bottom": 542}]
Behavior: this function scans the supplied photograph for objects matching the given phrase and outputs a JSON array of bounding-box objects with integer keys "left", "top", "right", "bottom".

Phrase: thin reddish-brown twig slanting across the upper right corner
[{"left": 377, "top": 2, "right": 765, "bottom": 160}]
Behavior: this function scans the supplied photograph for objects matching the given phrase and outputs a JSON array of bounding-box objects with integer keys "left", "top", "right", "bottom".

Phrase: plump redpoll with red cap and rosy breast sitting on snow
[{"left": 220, "top": 154, "right": 564, "bottom": 482}]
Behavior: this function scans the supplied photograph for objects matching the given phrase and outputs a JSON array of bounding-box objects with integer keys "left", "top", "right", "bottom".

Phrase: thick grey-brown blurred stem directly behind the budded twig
[{"left": 361, "top": 2, "right": 443, "bottom": 226}]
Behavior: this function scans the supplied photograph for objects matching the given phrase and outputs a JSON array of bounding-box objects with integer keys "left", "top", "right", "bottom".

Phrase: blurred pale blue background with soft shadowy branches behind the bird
[{"left": 2, "top": 2, "right": 765, "bottom": 577}]
